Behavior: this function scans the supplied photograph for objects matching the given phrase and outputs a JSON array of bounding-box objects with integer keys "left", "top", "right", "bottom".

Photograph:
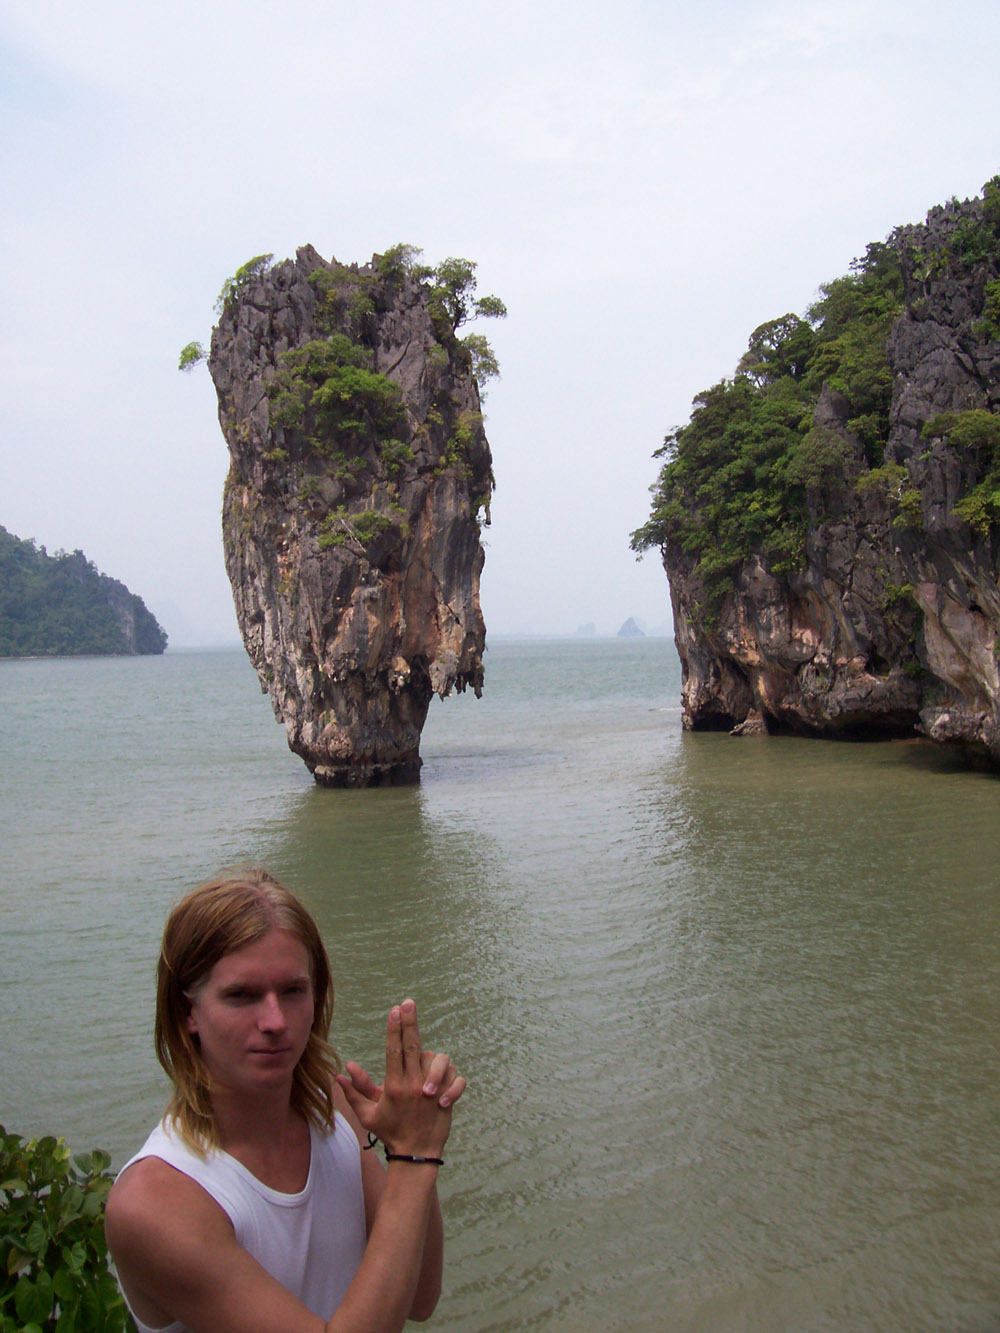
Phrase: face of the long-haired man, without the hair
[{"left": 187, "top": 930, "right": 313, "bottom": 1092}]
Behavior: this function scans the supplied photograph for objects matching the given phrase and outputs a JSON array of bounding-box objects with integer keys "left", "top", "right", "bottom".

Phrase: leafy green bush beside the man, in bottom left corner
[{"left": 0, "top": 1125, "right": 132, "bottom": 1333}]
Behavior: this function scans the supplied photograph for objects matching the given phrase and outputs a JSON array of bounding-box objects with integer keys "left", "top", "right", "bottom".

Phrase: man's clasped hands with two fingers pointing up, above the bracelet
[{"left": 337, "top": 1000, "right": 465, "bottom": 1157}]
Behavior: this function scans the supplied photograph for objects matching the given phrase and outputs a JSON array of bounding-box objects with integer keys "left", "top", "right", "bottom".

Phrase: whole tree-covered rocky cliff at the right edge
[{"left": 633, "top": 177, "right": 1000, "bottom": 764}]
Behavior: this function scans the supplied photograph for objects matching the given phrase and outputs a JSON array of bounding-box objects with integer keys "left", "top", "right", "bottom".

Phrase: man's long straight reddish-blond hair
[{"left": 155, "top": 866, "right": 340, "bottom": 1154}]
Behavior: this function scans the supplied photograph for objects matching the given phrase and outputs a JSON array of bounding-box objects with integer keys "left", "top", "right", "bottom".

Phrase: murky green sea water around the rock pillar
[{"left": 0, "top": 641, "right": 1000, "bottom": 1333}]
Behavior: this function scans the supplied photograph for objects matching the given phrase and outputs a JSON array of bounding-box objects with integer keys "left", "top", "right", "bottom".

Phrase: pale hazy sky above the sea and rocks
[{"left": 0, "top": 0, "right": 1000, "bottom": 644}]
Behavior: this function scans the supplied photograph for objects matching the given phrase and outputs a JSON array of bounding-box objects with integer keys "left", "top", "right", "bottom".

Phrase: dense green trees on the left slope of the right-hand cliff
[{"left": 632, "top": 223, "right": 903, "bottom": 593}]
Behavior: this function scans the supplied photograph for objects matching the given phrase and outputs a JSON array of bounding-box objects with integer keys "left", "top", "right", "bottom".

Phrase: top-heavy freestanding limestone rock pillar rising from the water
[{"left": 209, "top": 247, "right": 493, "bottom": 785}]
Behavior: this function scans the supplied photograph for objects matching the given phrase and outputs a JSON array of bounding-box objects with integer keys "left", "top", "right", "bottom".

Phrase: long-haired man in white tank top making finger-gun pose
[{"left": 105, "top": 870, "right": 465, "bottom": 1333}]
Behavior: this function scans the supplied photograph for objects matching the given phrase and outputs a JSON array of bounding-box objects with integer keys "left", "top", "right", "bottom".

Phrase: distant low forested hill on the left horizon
[{"left": 0, "top": 528, "right": 167, "bottom": 657}]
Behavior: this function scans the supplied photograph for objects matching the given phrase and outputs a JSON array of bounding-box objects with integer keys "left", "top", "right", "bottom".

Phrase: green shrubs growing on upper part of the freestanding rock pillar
[{"left": 216, "top": 244, "right": 507, "bottom": 551}]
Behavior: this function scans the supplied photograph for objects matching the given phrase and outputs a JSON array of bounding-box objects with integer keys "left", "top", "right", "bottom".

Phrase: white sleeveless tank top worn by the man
[{"left": 121, "top": 1112, "right": 367, "bottom": 1333}]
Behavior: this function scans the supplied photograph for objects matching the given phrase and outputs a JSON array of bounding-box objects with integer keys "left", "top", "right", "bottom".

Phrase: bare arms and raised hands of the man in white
[{"left": 105, "top": 1002, "right": 464, "bottom": 1333}]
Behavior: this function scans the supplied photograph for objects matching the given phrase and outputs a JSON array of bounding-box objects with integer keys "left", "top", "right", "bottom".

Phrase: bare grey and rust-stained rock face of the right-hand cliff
[{"left": 663, "top": 191, "right": 1000, "bottom": 765}]
